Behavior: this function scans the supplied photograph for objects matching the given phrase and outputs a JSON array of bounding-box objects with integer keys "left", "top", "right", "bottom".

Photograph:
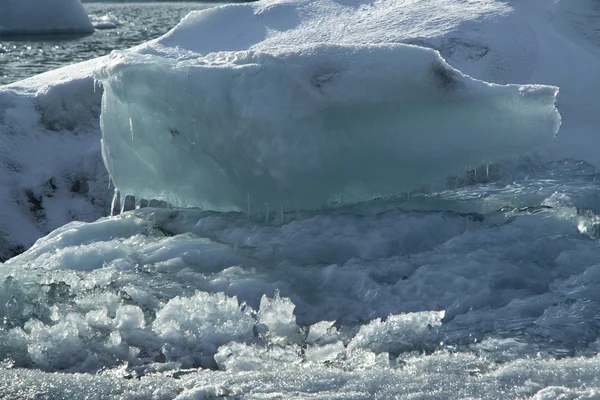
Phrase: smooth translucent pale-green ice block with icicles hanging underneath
[{"left": 96, "top": 44, "right": 560, "bottom": 212}]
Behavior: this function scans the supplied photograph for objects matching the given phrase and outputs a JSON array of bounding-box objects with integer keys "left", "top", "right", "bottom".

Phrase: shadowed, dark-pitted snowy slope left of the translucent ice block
[{"left": 0, "top": 60, "right": 110, "bottom": 261}]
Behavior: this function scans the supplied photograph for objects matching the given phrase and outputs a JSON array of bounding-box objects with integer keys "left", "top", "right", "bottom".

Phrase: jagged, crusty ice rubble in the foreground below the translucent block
[{"left": 0, "top": 163, "right": 600, "bottom": 399}]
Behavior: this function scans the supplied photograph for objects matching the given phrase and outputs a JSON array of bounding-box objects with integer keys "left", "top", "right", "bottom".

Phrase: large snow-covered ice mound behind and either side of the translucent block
[{"left": 0, "top": 0, "right": 600, "bottom": 259}]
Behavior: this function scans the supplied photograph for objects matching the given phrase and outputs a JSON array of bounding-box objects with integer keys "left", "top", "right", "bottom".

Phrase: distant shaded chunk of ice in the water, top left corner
[{"left": 0, "top": 0, "right": 94, "bottom": 35}]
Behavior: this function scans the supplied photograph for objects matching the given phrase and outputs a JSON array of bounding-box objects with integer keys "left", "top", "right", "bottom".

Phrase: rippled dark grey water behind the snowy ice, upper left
[{"left": 0, "top": 3, "right": 215, "bottom": 85}]
